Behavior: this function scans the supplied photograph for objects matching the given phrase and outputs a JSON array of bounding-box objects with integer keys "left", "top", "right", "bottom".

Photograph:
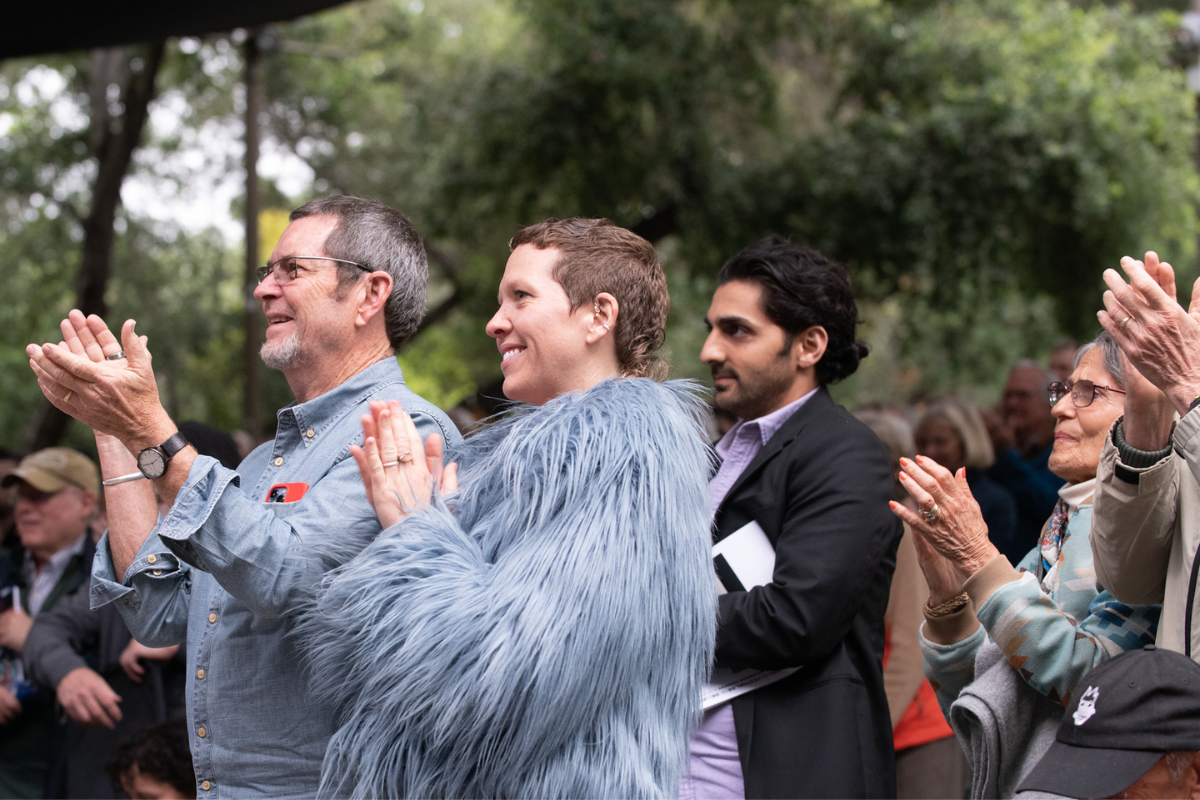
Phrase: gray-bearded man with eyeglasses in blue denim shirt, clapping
[{"left": 29, "top": 197, "right": 460, "bottom": 799}]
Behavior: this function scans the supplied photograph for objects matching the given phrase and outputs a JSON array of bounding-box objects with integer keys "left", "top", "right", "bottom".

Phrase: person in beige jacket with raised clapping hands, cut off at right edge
[{"left": 1092, "top": 252, "right": 1200, "bottom": 662}]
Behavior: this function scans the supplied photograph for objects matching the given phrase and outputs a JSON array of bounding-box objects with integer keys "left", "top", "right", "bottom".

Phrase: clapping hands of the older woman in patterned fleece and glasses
[{"left": 888, "top": 456, "right": 1000, "bottom": 606}]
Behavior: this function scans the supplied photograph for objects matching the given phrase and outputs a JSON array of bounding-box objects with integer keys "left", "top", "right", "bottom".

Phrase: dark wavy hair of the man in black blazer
[{"left": 716, "top": 236, "right": 866, "bottom": 384}]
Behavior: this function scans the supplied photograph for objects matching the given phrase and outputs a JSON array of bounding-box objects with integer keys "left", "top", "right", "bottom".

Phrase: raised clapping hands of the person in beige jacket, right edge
[{"left": 1097, "top": 252, "right": 1200, "bottom": 417}]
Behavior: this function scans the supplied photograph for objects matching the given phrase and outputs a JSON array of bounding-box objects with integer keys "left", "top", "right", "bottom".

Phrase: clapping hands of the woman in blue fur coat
[{"left": 350, "top": 399, "right": 458, "bottom": 528}]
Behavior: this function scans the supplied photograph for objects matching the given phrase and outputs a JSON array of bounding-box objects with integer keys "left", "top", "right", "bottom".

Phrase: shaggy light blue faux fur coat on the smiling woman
[{"left": 301, "top": 378, "right": 716, "bottom": 798}]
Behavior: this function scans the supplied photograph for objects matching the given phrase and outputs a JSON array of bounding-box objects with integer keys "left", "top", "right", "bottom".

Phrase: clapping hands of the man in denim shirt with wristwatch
[{"left": 25, "top": 309, "right": 169, "bottom": 444}]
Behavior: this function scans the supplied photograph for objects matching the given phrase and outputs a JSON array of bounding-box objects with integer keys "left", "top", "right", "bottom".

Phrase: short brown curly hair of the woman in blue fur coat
[{"left": 509, "top": 217, "right": 671, "bottom": 380}]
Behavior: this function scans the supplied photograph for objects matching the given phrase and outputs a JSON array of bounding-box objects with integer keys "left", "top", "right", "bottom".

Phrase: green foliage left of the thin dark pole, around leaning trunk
[{"left": 0, "top": 50, "right": 250, "bottom": 450}]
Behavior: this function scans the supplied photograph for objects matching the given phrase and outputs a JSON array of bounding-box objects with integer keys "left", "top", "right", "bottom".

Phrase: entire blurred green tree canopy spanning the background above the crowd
[{"left": 0, "top": 0, "right": 1200, "bottom": 444}]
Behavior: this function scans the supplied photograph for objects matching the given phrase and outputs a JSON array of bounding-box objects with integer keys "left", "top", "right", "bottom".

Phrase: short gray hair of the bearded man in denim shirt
[{"left": 289, "top": 196, "right": 430, "bottom": 350}]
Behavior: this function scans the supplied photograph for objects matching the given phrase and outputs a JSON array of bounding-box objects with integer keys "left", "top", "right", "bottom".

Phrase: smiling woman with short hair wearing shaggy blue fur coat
[{"left": 302, "top": 219, "right": 716, "bottom": 798}]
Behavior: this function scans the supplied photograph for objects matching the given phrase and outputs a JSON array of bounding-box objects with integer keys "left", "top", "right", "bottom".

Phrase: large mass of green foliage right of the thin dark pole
[{"left": 262, "top": 0, "right": 1198, "bottom": 398}]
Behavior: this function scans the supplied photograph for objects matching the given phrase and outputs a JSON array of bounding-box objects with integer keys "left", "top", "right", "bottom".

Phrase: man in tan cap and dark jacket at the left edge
[{"left": 0, "top": 447, "right": 100, "bottom": 798}]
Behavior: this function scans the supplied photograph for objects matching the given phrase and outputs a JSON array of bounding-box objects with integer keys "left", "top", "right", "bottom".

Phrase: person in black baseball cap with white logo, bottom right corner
[{"left": 1019, "top": 644, "right": 1200, "bottom": 798}]
